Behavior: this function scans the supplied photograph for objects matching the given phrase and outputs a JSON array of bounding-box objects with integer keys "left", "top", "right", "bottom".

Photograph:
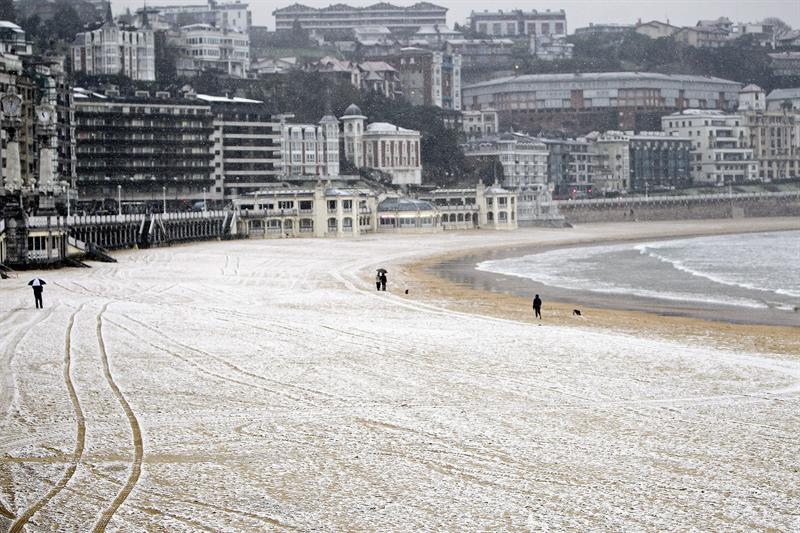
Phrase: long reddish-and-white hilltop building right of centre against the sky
[{"left": 469, "top": 9, "right": 567, "bottom": 37}]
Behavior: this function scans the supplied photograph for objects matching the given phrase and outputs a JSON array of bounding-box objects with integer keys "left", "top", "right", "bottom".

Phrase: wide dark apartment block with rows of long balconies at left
[{"left": 74, "top": 90, "right": 214, "bottom": 207}]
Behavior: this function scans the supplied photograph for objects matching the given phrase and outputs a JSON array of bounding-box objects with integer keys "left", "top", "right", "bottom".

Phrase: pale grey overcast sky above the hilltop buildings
[{"left": 112, "top": 0, "right": 800, "bottom": 33}]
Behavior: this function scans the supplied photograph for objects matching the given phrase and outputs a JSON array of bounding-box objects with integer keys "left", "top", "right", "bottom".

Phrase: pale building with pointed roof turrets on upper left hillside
[{"left": 72, "top": 21, "right": 156, "bottom": 81}]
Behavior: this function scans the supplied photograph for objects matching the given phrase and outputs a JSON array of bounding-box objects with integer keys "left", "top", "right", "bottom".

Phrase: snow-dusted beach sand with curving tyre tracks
[{"left": 0, "top": 218, "right": 800, "bottom": 531}]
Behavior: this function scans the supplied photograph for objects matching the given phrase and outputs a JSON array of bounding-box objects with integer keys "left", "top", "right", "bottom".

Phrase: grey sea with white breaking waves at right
[{"left": 477, "top": 231, "right": 800, "bottom": 325}]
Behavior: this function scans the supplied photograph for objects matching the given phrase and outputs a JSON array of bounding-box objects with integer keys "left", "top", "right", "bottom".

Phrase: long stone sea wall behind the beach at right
[{"left": 555, "top": 191, "right": 800, "bottom": 224}]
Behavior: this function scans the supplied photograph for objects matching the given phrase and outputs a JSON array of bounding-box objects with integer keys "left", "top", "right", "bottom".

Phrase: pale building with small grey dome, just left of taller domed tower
[{"left": 282, "top": 115, "right": 339, "bottom": 176}]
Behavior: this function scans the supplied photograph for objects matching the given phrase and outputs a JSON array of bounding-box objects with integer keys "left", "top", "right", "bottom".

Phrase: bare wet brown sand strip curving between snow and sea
[{"left": 403, "top": 218, "right": 800, "bottom": 356}]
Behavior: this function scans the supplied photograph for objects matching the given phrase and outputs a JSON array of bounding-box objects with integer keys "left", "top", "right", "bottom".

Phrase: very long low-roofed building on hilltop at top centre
[{"left": 272, "top": 2, "right": 447, "bottom": 34}]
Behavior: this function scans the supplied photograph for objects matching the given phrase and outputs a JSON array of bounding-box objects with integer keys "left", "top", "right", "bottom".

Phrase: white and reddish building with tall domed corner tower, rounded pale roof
[{"left": 341, "top": 104, "right": 422, "bottom": 185}]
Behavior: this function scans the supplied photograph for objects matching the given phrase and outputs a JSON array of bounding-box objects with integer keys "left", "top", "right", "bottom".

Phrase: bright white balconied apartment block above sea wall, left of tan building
[{"left": 661, "top": 109, "right": 758, "bottom": 186}]
